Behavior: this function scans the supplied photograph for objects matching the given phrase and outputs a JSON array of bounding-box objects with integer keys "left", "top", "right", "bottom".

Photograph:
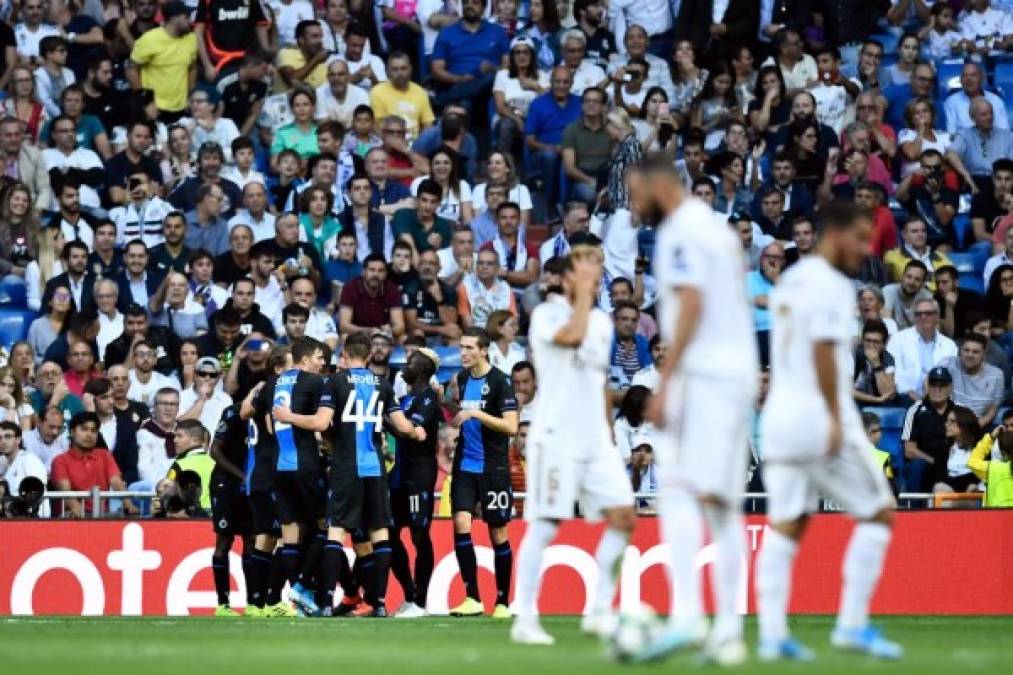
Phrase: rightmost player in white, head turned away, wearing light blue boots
[{"left": 757, "top": 202, "right": 903, "bottom": 661}]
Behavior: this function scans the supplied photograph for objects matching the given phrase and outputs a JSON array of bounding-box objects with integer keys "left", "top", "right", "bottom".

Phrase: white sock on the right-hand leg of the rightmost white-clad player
[{"left": 837, "top": 523, "right": 890, "bottom": 628}]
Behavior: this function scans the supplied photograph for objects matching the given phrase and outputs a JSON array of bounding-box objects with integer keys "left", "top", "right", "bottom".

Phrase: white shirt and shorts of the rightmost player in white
[{"left": 761, "top": 255, "right": 893, "bottom": 522}]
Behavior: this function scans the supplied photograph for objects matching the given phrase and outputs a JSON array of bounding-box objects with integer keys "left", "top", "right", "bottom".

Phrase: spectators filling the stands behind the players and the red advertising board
[{"left": 0, "top": 0, "right": 1013, "bottom": 517}]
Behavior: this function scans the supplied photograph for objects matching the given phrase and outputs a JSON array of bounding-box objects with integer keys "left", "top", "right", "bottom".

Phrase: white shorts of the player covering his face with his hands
[{"left": 524, "top": 434, "right": 633, "bottom": 521}]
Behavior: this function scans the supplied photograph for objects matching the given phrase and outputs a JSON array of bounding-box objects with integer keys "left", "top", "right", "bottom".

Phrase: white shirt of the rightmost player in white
[{"left": 764, "top": 255, "right": 861, "bottom": 459}]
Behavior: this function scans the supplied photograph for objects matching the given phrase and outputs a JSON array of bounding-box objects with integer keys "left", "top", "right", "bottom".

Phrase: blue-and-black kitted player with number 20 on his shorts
[{"left": 450, "top": 327, "right": 518, "bottom": 619}]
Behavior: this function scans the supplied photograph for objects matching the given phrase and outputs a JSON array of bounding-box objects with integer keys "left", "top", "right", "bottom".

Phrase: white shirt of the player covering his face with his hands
[{"left": 528, "top": 295, "right": 614, "bottom": 456}]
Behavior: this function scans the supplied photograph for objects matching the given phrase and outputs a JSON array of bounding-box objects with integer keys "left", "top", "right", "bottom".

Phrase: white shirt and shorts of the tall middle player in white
[{"left": 654, "top": 199, "right": 758, "bottom": 496}]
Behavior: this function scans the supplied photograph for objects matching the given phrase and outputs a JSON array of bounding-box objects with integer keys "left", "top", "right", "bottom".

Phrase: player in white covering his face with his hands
[{"left": 511, "top": 244, "right": 636, "bottom": 645}]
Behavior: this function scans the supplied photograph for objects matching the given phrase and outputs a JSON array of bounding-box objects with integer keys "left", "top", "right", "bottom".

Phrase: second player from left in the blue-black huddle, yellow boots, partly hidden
[{"left": 239, "top": 346, "right": 296, "bottom": 618}]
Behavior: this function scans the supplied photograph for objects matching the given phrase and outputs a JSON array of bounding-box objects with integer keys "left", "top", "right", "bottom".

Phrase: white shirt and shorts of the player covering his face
[{"left": 524, "top": 295, "right": 633, "bottom": 521}]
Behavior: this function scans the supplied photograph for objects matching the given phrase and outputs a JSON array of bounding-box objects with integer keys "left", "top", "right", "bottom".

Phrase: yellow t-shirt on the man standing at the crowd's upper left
[{"left": 130, "top": 28, "right": 197, "bottom": 113}]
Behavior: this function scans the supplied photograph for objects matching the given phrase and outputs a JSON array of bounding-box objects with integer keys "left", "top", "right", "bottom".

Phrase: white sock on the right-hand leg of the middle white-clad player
[{"left": 703, "top": 505, "right": 746, "bottom": 643}]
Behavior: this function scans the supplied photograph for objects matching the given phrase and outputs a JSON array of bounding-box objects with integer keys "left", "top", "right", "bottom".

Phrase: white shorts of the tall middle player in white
[{"left": 654, "top": 375, "right": 756, "bottom": 499}]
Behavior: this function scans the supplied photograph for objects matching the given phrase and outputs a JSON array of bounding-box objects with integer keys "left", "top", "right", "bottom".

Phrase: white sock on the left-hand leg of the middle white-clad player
[{"left": 658, "top": 489, "right": 703, "bottom": 630}]
